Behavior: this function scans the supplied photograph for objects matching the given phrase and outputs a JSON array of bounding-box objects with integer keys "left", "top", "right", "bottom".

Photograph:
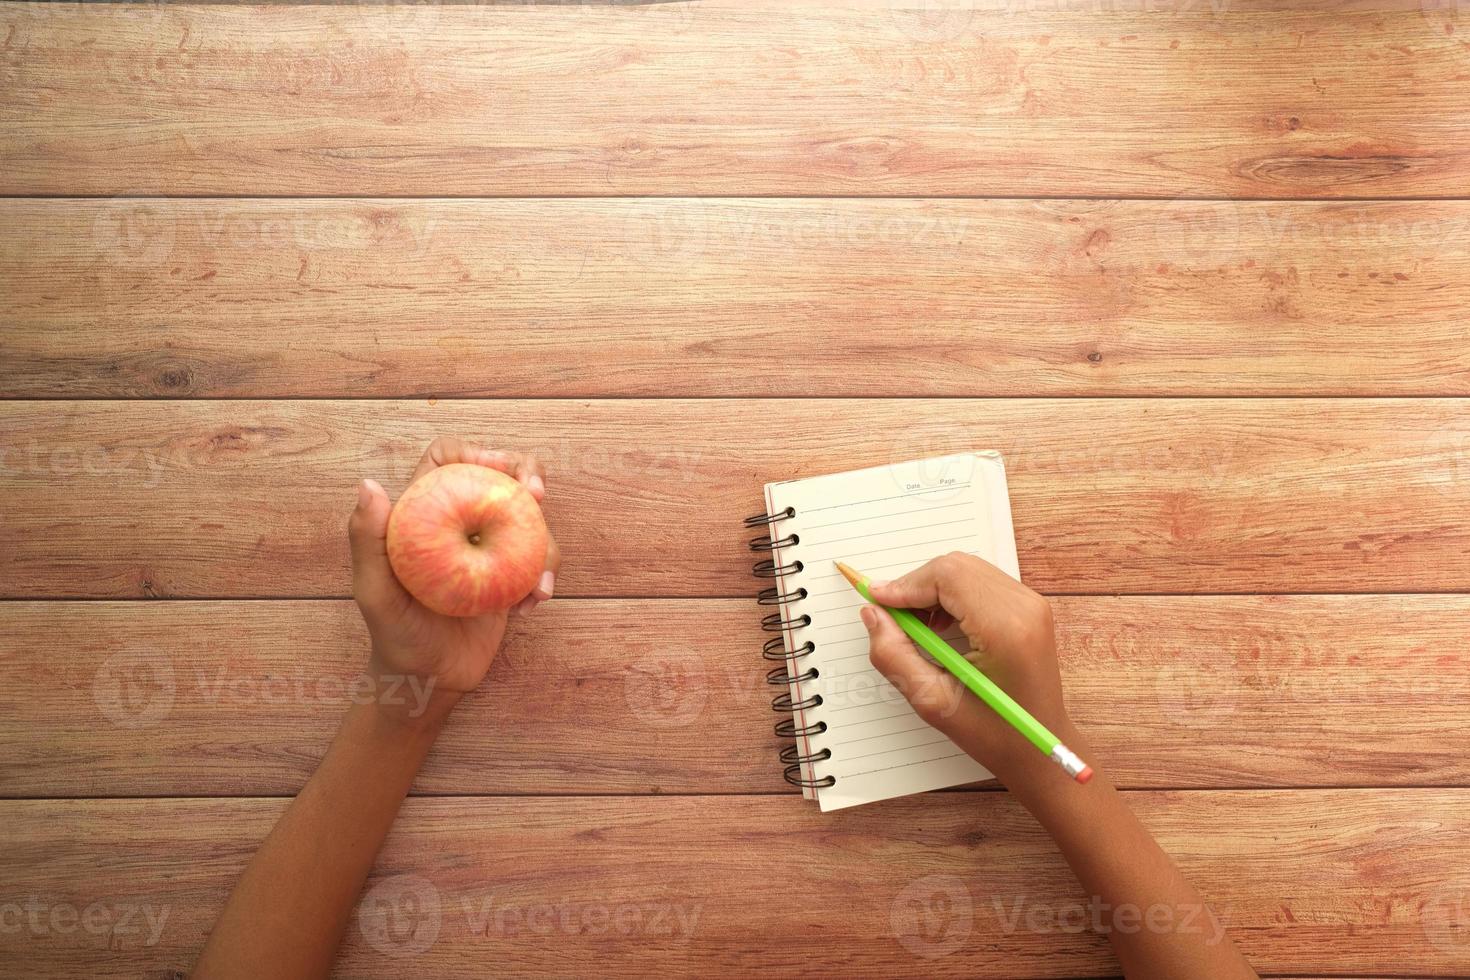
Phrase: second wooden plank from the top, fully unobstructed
[{"left": 0, "top": 198, "right": 1470, "bottom": 397}]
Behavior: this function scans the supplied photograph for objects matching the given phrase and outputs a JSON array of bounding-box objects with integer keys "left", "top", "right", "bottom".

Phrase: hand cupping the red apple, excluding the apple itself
[{"left": 347, "top": 438, "right": 562, "bottom": 714}]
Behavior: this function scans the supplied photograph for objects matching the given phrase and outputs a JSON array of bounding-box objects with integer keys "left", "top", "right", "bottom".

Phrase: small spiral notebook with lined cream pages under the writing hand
[{"left": 745, "top": 453, "right": 1020, "bottom": 811}]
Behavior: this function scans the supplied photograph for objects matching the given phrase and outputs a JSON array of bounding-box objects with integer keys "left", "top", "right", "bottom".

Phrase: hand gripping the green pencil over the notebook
[{"left": 863, "top": 552, "right": 1072, "bottom": 783}]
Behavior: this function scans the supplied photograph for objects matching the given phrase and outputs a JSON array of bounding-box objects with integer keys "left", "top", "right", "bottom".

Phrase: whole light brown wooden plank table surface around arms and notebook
[{"left": 0, "top": 0, "right": 1470, "bottom": 977}]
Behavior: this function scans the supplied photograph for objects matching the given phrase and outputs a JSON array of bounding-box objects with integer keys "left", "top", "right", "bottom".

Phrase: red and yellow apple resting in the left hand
[{"left": 388, "top": 463, "right": 547, "bottom": 616}]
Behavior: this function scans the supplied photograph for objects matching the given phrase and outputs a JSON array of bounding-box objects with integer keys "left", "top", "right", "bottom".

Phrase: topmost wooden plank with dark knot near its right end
[{"left": 0, "top": 0, "right": 1470, "bottom": 198}]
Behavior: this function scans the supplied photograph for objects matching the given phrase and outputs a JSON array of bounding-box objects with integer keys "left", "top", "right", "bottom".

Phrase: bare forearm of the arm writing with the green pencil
[{"left": 1003, "top": 729, "right": 1255, "bottom": 980}]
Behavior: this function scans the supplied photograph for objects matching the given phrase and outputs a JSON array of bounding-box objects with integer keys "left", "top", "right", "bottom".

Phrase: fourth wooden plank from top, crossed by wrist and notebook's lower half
[{"left": 0, "top": 595, "right": 1470, "bottom": 796}]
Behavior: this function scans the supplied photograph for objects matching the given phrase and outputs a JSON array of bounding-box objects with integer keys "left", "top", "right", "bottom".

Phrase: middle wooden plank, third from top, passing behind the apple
[{"left": 0, "top": 398, "right": 1470, "bottom": 598}]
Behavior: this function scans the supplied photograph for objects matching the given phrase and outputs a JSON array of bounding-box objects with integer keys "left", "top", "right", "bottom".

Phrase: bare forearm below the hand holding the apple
[{"left": 194, "top": 690, "right": 453, "bottom": 980}]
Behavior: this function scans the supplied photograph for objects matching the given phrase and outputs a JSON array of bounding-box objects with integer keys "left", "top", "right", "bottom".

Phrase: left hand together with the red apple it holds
[{"left": 347, "top": 438, "right": 562, "bottom": 717}]
